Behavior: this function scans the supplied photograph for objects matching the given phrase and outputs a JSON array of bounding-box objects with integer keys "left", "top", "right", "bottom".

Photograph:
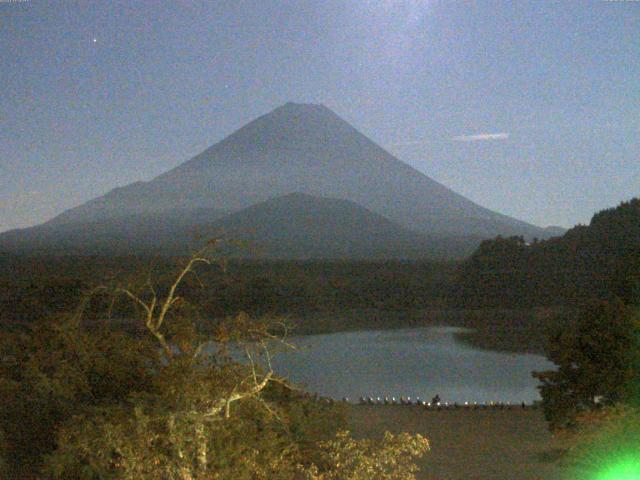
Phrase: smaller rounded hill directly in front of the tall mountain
[{"left": 209, "top": 193, "right": 480, "bottom": 260}]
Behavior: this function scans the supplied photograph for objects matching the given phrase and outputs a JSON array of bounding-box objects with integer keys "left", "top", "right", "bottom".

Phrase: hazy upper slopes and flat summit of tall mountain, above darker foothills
[{"left": 43, "top": 104, "right": 547, "bottom": 238}]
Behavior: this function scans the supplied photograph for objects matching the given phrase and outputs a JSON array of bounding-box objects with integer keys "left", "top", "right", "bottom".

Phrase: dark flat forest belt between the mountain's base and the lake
[{"left": 0, "top": 257, "right": 457, "bottom": 334}]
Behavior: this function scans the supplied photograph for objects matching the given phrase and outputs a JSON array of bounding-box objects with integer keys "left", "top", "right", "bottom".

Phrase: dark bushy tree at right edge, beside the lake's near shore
[{"left": 533, "top": 299, "right": 640, "bottom": 430}]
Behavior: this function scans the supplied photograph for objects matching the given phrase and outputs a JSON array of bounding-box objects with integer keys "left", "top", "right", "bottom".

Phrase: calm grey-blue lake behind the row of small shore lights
[{"left": 273, "top": 327, "right": 553, "bottom": 403}]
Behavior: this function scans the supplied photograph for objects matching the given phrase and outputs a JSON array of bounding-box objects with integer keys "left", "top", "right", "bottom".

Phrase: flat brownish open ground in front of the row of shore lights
[{"left": 348, "top": 405, "right": 562, "bottom": 480}]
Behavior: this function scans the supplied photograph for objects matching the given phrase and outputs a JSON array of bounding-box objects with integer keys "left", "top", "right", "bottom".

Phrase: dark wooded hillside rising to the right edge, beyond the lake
[{"left": 454, "top": 198, "right": 640, "bottom": 306}]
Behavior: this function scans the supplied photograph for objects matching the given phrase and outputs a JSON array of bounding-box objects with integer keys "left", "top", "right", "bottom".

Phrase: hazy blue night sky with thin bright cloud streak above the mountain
[{"left": 0, "top": 0, "right": 640, "bottom": 231}]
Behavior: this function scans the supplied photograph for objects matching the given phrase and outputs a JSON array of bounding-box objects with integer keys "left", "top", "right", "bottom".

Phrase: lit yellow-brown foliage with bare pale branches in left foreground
[{"left": 0, "top": 249, "right": 428, "bottom": 480}]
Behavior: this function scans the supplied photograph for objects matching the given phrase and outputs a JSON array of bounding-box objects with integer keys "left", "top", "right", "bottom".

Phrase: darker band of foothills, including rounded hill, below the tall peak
[{"left": 0, "top": 193, "right": 481, "bottom": 259}]
